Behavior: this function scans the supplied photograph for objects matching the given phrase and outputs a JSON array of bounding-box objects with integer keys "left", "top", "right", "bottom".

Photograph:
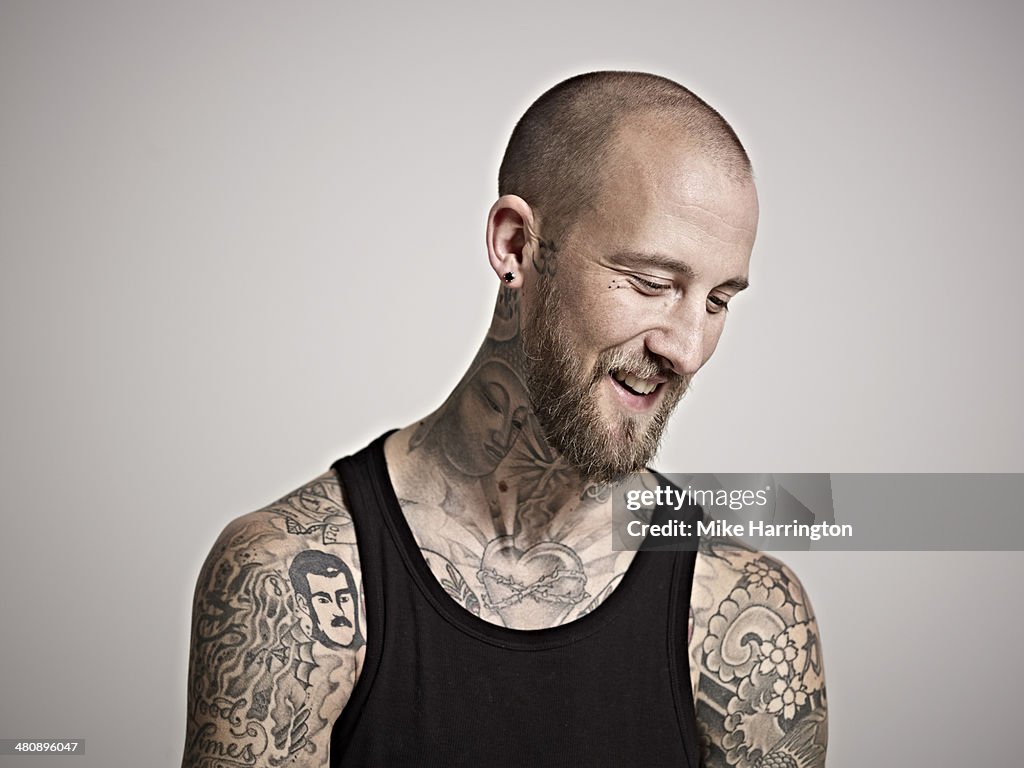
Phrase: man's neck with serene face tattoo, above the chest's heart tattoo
[{"left": 388, "top": 288, "right": 607, "bottom": 546}]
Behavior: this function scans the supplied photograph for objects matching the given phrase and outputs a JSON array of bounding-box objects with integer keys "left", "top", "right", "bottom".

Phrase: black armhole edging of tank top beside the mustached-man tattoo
[{"left": 330, "top": 430, "right": 395, "bottom": 766}]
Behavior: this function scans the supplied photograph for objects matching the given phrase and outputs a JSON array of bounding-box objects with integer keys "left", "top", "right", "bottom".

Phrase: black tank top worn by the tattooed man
[{"left": 331, "top": 435, "right": 699, "bottom": 768}]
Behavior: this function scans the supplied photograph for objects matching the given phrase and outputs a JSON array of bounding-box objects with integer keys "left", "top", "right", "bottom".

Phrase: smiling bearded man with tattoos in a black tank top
[{"left": 183, "top": 73, "right": 826, "bottom": 767}]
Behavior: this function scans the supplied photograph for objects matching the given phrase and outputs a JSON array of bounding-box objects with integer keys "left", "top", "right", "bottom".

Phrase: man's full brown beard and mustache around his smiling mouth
[{"left": 522, "top": 274, "right": 690, "bottom": 483}]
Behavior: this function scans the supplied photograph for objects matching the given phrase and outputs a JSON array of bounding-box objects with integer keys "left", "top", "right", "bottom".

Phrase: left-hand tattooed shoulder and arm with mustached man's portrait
[{"left": 182, "top": 473, "right": 365, "bottom": 768}]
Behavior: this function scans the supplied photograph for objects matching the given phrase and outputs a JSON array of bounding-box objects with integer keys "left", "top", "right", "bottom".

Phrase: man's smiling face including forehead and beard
[{"left": 522, "top": 119, "right": 758, "bottom": 481}]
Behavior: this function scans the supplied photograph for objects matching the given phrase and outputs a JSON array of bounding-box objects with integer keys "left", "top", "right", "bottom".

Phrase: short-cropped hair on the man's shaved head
[{"left": 498, "top": 72, "right": 752, "bottom": 238}]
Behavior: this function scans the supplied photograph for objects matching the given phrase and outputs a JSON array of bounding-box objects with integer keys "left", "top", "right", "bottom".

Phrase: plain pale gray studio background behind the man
[{"left": 0, "top": 0, "right": 1024, "bottom": 767}]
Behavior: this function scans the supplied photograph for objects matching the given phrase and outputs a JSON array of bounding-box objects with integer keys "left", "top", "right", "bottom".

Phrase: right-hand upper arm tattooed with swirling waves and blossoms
[{"left": 690, "top": 540, "right": 827, "bottom": 768}]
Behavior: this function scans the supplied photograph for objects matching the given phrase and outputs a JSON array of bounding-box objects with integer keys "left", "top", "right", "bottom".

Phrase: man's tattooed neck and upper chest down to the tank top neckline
[{"left": 384, "top": 289, "right": 651, "bottom": 629}]
